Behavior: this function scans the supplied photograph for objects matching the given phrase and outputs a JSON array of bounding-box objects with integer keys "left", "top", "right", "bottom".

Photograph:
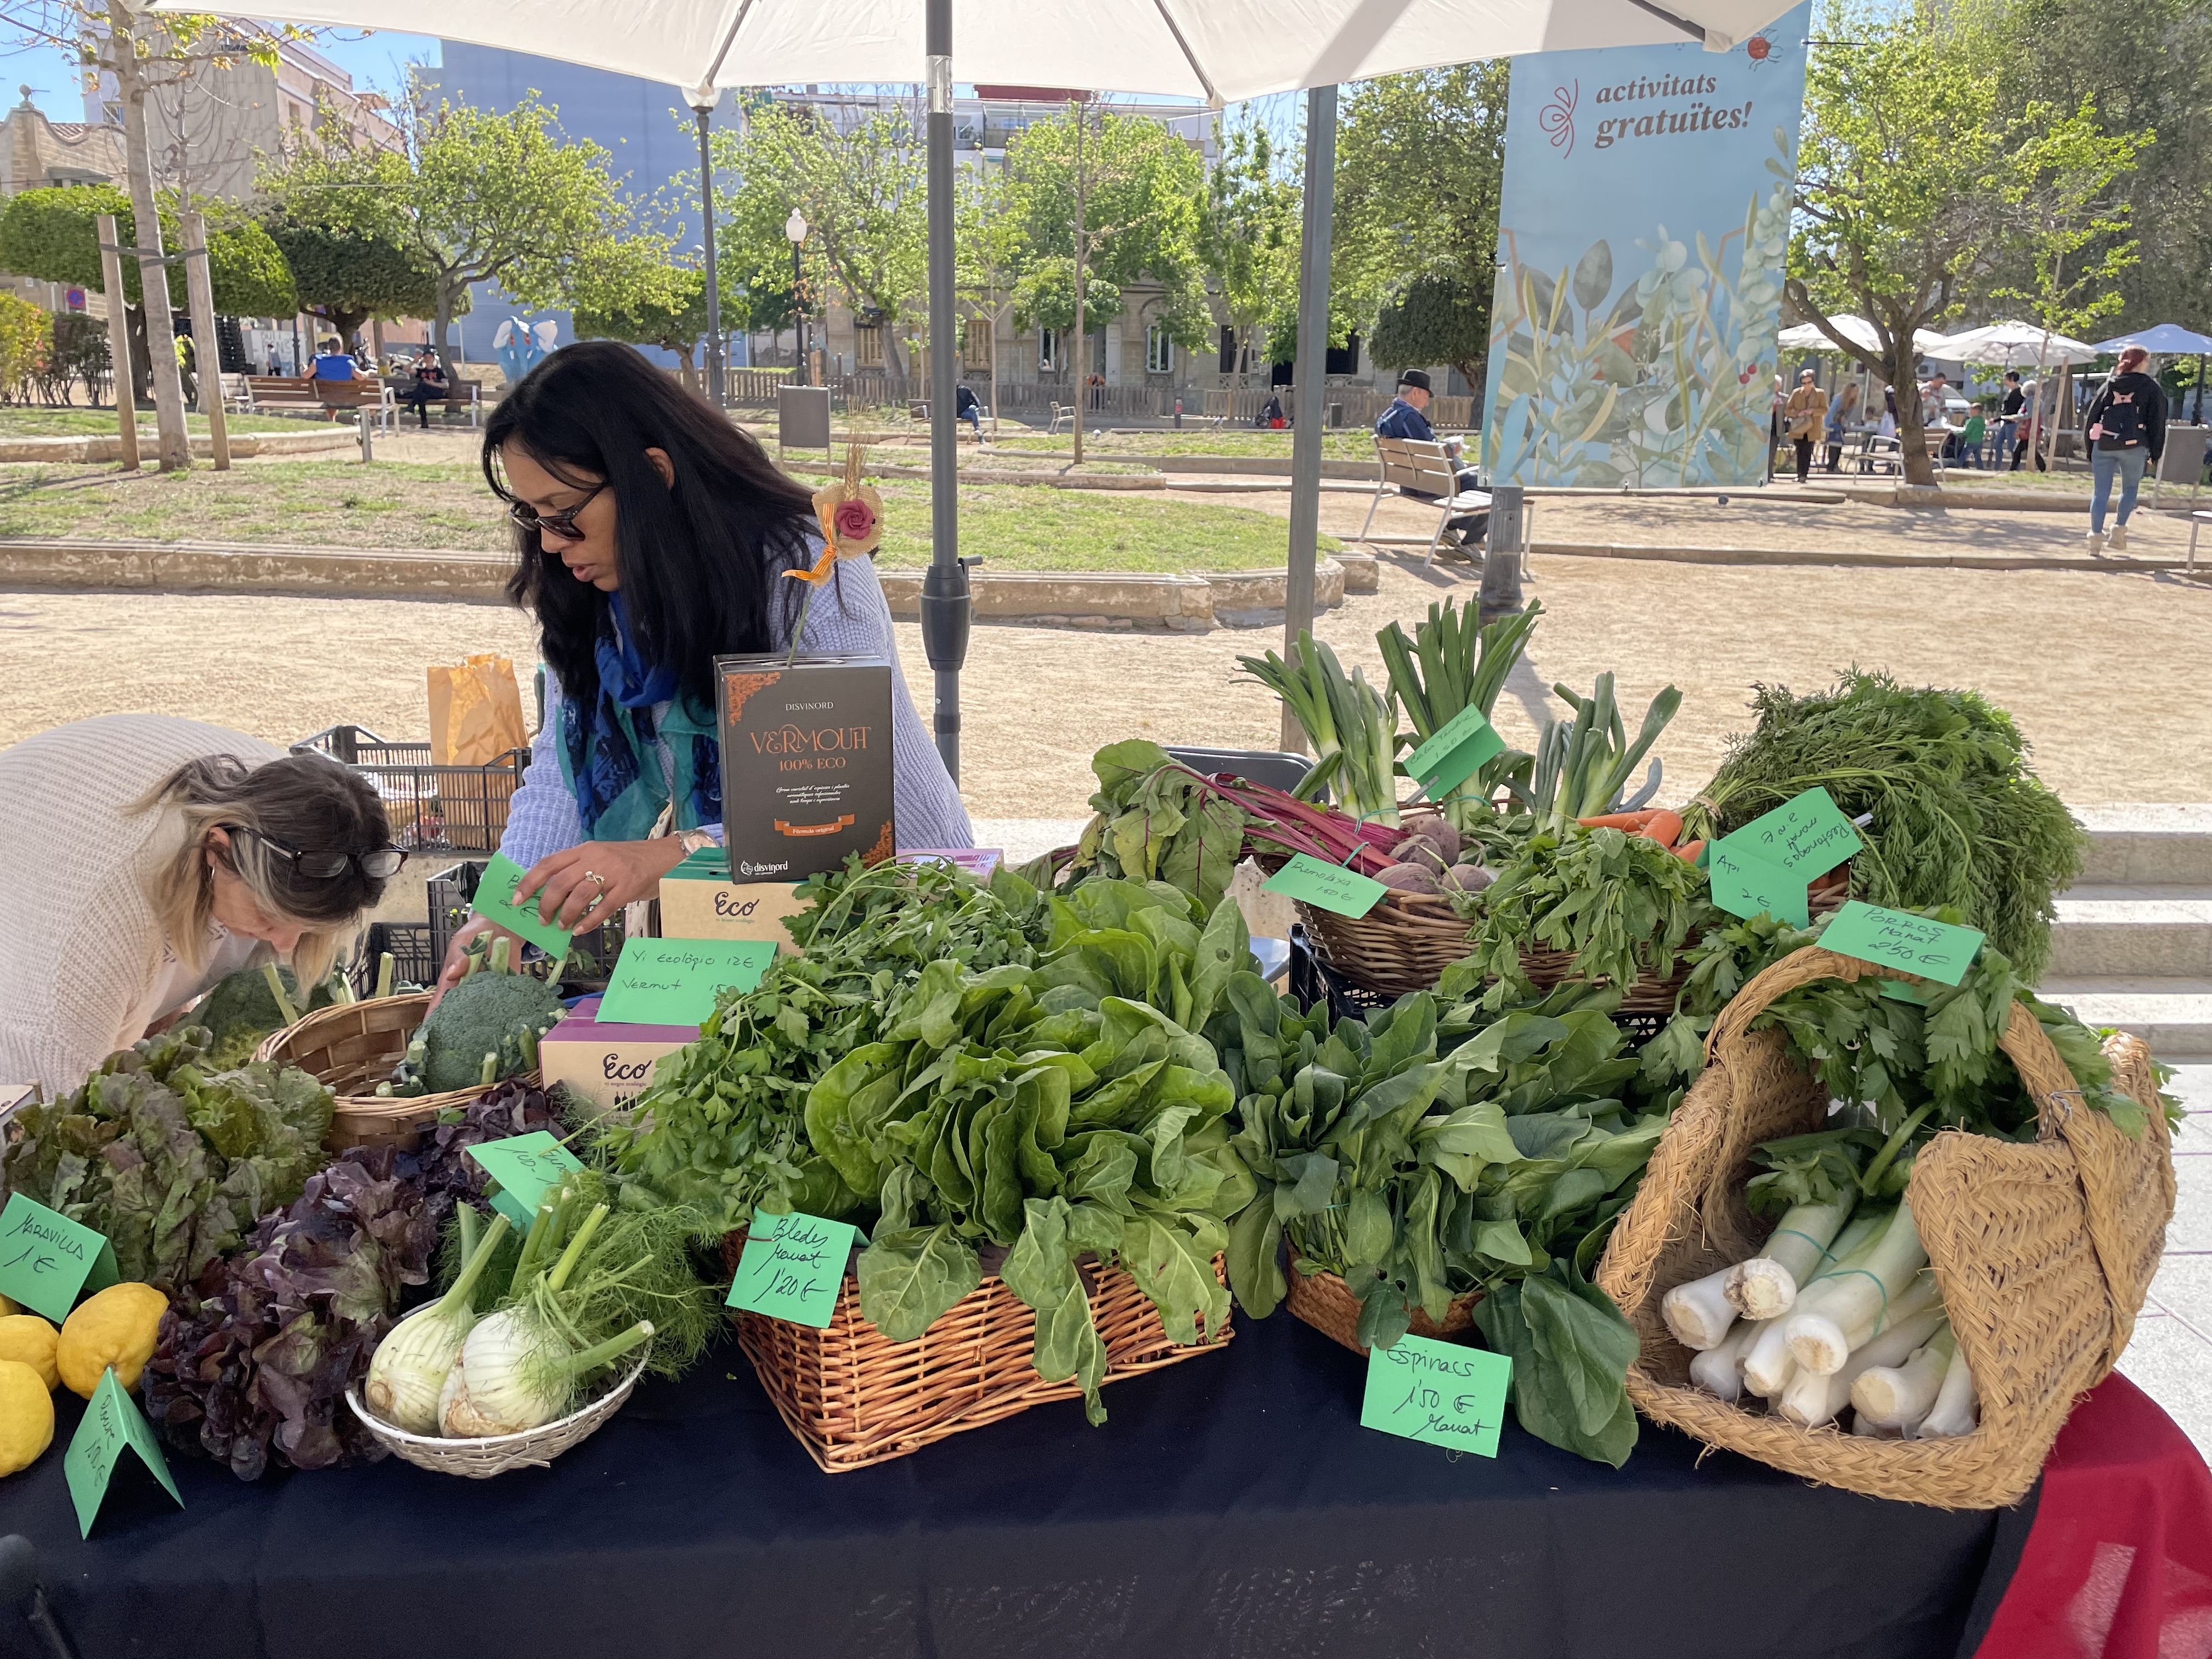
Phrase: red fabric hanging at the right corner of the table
[{"left": 1976, "top": 1374, "right": 2212, "bottom": 1659}]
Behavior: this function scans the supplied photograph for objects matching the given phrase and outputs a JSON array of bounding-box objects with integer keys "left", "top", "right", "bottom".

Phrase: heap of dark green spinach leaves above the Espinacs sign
[{"left": 1210, "top": 973, "right": 1666, "bottom": 1464}]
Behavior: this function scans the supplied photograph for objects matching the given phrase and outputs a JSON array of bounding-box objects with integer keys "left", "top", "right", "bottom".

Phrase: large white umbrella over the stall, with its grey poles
[{"left": 168, "top": 0, "right": 1790, "bottom": 778}]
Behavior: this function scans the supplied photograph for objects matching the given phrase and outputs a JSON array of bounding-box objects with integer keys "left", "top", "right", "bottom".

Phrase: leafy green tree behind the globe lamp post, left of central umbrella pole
[{"left": 714, "top": 104, "right": 929, "bottom": 374}]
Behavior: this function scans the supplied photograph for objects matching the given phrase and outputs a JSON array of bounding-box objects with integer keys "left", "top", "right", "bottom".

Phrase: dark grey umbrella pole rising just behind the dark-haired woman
[{"left": 922, "top": 0, "right": 971, "bottom": 783}]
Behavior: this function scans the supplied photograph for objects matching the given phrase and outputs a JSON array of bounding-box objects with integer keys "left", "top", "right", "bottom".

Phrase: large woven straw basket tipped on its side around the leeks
[{"left": 1597, "top": 947, "right": 2174, "bottom": 1509}]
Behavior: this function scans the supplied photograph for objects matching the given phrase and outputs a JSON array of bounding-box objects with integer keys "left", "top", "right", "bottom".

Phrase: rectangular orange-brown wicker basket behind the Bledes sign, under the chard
[{"left": 721, "top": 1232, "right": 1234, "bottom": 1473}]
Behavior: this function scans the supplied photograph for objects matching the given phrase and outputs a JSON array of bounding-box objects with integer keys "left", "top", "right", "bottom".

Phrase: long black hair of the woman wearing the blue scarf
[{"left": 484, "top": 341, "right": 814, "bottom": 710}]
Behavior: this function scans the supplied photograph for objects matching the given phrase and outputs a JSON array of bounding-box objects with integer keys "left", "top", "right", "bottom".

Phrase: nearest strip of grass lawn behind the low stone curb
[{"left": 0, "top": 460, "right": 1336, "bottom": 571}]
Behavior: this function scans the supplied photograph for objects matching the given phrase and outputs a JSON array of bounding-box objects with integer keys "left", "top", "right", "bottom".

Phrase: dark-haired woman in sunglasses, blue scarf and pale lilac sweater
[{"left": 440, "top": 341, "right": 973, "bottom": 986}]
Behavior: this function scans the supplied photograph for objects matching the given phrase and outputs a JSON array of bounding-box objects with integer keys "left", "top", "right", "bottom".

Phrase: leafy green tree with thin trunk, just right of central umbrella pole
[{"left": 1007, "top": 104, "right": 1205, "bottom": 462}]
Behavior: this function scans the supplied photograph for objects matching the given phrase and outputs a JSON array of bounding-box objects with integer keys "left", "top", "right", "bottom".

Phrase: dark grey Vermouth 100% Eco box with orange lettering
[{"left": 725, "top": 657, "right": 896, "bottom": 884}]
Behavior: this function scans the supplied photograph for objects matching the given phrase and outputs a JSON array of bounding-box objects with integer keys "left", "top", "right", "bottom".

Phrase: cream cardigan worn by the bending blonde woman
[{"left": 0, "top": 714, "right": 283, "bottom": 1099}]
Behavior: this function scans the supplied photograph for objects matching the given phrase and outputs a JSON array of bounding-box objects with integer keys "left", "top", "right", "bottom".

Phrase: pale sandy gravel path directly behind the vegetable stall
[{"left": 0, "top": 553, "right": 2212, "bottom": 819}]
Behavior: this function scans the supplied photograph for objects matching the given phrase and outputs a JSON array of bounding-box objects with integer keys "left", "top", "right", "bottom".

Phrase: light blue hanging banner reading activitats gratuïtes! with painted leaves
[{"left": 1482, "top": 7, "right": 1809, "bottom": 487}]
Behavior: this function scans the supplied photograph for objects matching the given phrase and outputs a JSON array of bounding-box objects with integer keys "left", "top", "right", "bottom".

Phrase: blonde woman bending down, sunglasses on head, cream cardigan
[{"left": 0, "top": 714, "right": 405, "bottom": 1097}]
